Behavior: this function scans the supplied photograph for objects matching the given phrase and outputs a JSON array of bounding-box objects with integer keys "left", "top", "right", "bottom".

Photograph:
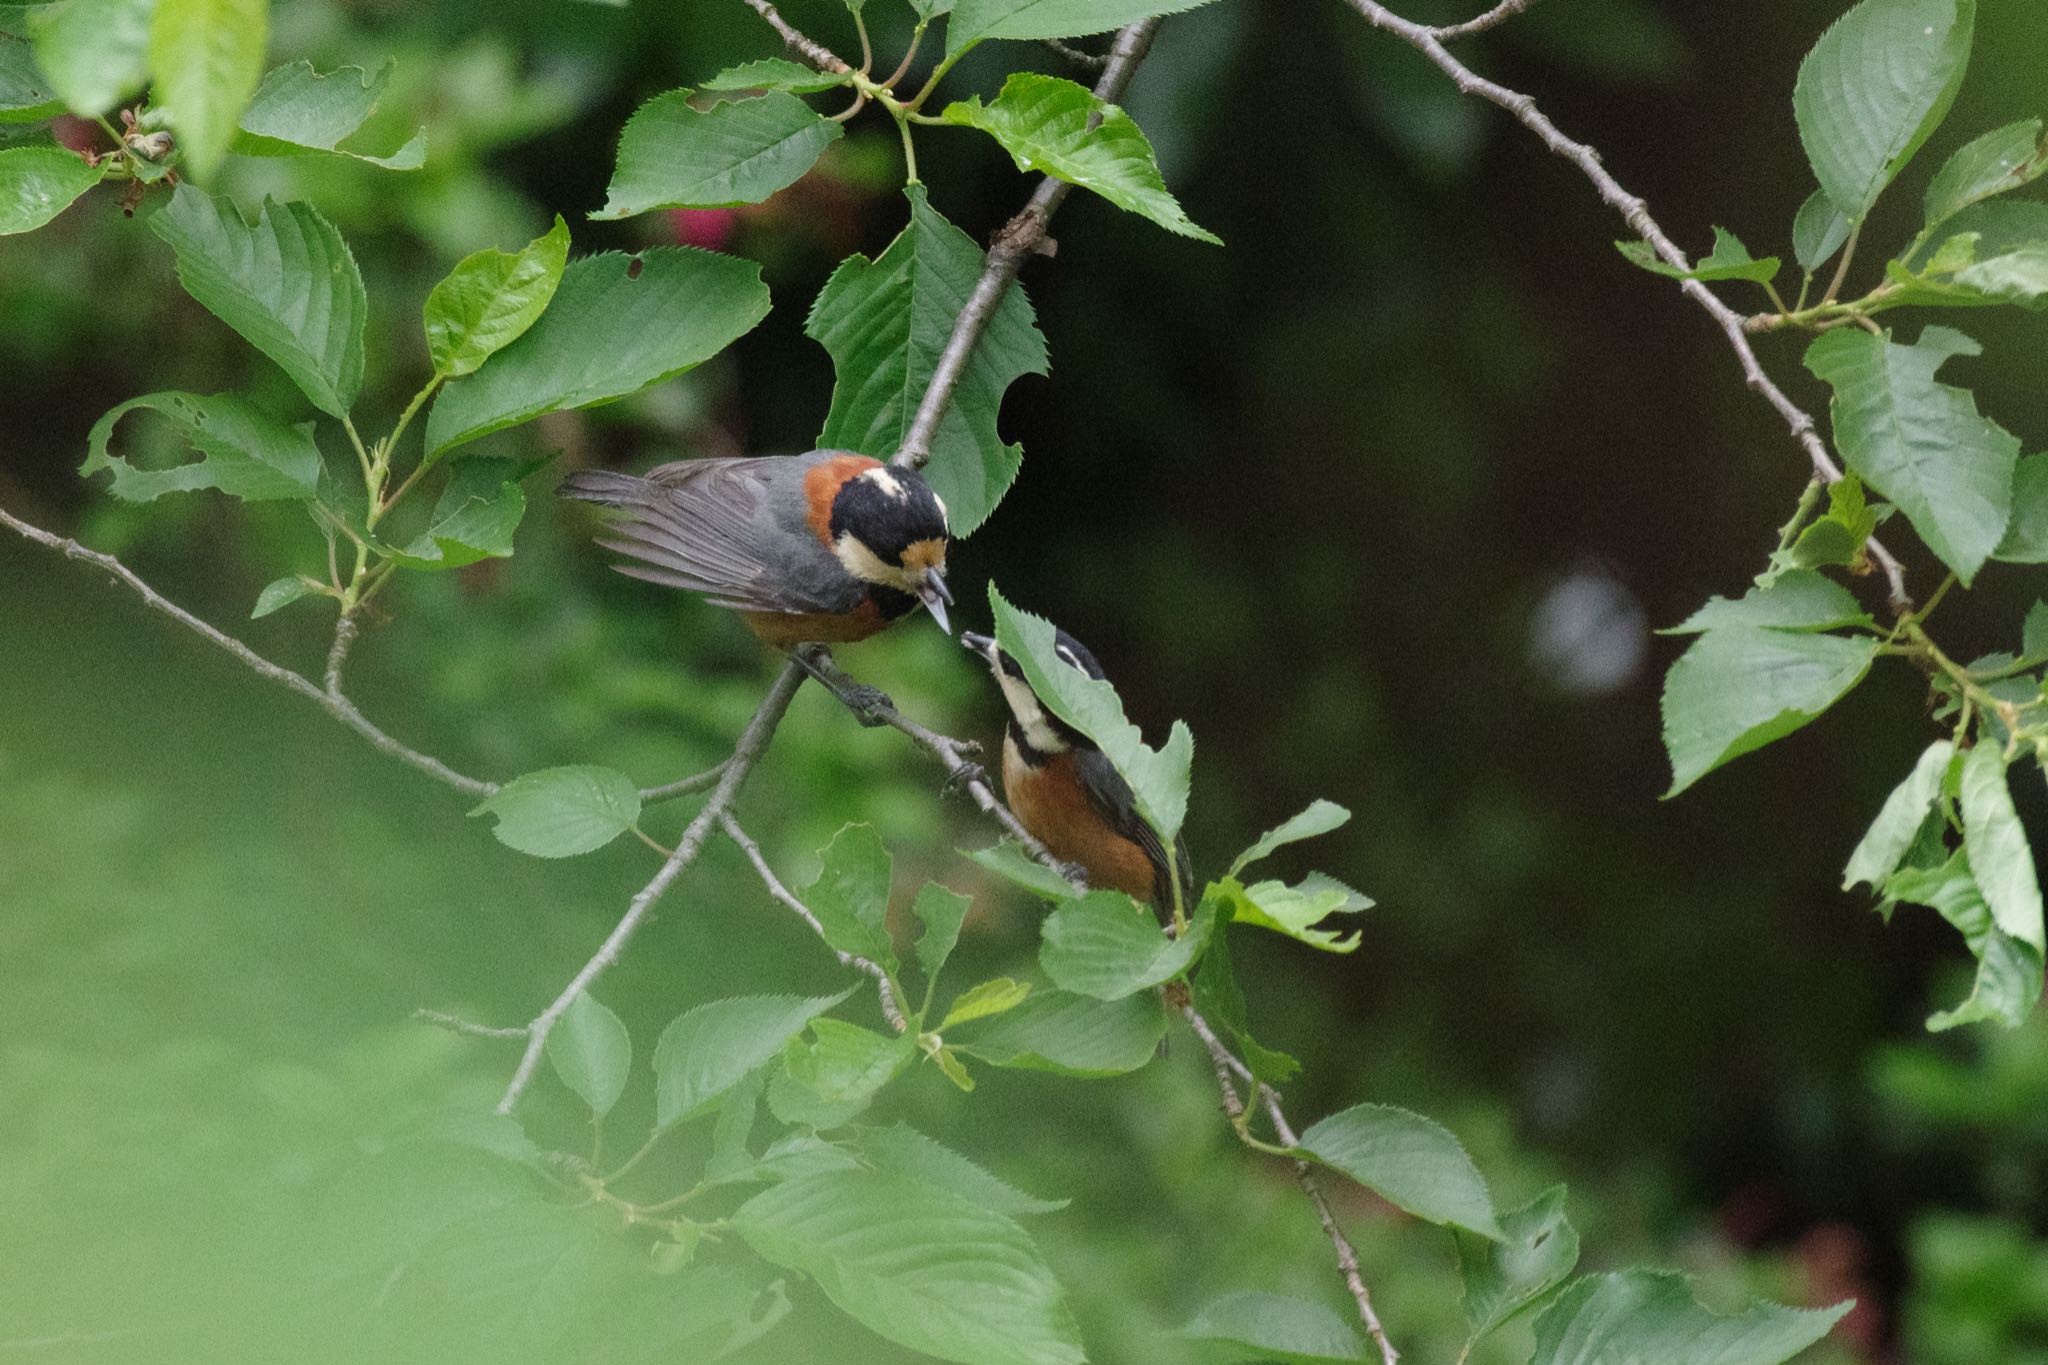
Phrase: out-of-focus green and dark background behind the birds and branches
[{"left": 0, "top": 0, "right": 2048, "bottom": 1365}]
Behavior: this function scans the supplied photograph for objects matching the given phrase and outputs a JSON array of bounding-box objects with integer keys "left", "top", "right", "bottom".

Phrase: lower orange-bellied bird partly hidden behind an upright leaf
[{"left": 961, "top": 630, "right": 1194, "bottom": 911}]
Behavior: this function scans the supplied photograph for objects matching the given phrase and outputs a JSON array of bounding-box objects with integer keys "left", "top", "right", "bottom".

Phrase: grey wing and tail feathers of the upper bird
[{"left": 559, "top": 456, "right": 858, "bottom": 612}]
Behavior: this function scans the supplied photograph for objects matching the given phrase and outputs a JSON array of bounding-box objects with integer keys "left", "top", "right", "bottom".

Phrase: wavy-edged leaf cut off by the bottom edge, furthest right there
[{"left": 1532, "top": 1271, "right": 1853, "bottom": 1365}]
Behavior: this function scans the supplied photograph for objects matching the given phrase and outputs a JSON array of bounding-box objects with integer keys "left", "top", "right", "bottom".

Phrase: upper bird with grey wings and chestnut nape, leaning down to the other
[{"left": 557, "top": 450, "right": 952, "bottom": 710}]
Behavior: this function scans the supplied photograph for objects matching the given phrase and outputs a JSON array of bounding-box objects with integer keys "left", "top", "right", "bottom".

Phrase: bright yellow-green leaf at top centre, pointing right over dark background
[{"left": 940, "top": 72, "right": 1223, "bottom": 246}]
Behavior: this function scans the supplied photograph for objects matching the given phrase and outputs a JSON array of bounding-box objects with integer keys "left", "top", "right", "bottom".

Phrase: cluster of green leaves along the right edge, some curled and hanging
[{"left": 1622, "top": 0, "right": 2048, "bottom": 1029}]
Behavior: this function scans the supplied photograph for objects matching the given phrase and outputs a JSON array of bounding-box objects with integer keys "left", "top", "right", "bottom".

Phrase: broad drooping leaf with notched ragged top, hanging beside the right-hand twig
[{"left": 1806, "top": 327, "right": 2019, "bottom": 587}]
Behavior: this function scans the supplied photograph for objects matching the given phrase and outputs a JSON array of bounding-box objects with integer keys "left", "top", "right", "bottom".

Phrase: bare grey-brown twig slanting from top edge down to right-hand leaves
[{"left": 1343, "top": 0, "right": 1913, "bottom": 614}]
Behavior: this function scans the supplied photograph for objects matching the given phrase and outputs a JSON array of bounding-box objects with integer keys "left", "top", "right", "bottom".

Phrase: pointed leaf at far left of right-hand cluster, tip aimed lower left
[{"left": 1663, "top": 626, "right": 1878, "bottom": 798}]
